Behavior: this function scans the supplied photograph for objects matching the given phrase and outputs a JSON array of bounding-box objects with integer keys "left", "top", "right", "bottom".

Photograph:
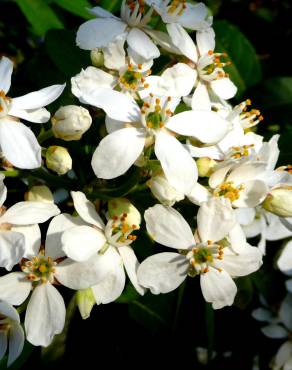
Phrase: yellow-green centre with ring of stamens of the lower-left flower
[{"left": 21, "top": 253, "right": 57, "bottom": 283}]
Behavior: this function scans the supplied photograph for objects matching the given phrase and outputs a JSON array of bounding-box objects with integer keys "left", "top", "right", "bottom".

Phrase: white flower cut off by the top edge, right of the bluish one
[{"left": 145, "top": 0, "right": 212, "bottom": 30}]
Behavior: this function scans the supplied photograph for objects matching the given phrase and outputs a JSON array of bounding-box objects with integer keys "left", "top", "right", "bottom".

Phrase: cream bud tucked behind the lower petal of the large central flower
[{"left": 147, "top": 173, "right": 185, "bottom": 206}]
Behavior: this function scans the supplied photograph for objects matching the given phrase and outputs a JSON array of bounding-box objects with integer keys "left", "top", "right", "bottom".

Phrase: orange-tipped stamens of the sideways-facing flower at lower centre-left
[{"left": 105, "top": 213, "right": 138, "bottom": 247}]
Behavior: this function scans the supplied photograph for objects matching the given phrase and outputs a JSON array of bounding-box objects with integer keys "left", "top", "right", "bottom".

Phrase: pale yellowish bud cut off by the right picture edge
[{"left": 262, "top": 185, "right": 292, "bottom": 217}]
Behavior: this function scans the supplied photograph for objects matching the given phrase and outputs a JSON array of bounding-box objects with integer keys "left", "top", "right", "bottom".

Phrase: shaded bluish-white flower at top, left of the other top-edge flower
[{"left": 76, "top": 0, "right": 160, "bottom": 60}]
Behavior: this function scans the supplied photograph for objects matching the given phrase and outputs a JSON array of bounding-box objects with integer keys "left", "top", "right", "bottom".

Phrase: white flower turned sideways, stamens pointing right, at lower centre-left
[{"left": 58, "top": 191, "right": 144, "bottom": 304}]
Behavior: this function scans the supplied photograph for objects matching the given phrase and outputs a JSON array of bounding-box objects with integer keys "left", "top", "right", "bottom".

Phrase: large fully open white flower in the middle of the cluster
[{"left": 92, "top": 94, "right": 228, "bottom": 193}]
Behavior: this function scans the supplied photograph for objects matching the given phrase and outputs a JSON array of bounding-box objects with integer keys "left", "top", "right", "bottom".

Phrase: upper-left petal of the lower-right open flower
[{"left": 144, "top": 204, "right": 195, "bottom": 249}]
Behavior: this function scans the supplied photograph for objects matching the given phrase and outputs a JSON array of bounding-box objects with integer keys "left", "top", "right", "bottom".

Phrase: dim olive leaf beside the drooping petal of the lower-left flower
[{"left": 42, "top": 294, "right": 77, "bottom": 364}]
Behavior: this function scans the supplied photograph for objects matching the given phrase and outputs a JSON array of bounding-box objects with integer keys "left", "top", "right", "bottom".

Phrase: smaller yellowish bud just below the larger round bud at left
[{"left": 46, "top": 145, "right": 72, "bottom": 175}]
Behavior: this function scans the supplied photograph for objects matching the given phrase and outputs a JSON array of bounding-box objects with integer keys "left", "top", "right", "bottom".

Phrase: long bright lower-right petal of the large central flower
[{"left": 154, "top": 131, "right": 198, "bottom": 194}]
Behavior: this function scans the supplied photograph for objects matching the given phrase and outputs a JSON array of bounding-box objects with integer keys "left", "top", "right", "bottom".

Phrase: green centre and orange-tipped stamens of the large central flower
[{"left": 141, "top": 96, "right": 173, "bottom": 131}]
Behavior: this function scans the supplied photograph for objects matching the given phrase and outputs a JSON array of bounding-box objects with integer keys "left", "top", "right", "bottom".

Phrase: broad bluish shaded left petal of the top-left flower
[{"left": 76, "top": 18, "right": 127, "bottom": 50}]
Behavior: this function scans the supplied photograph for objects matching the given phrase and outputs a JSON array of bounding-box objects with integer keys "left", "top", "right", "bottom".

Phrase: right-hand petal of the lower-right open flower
[{"left": 216, "top": 244, "right": 262, "bottom": 277}]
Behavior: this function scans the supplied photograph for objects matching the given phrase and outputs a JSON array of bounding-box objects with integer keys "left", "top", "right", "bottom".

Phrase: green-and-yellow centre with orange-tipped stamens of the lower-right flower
[{"left": 186, "top": 240, "right": 224, "bottom": 276}]
